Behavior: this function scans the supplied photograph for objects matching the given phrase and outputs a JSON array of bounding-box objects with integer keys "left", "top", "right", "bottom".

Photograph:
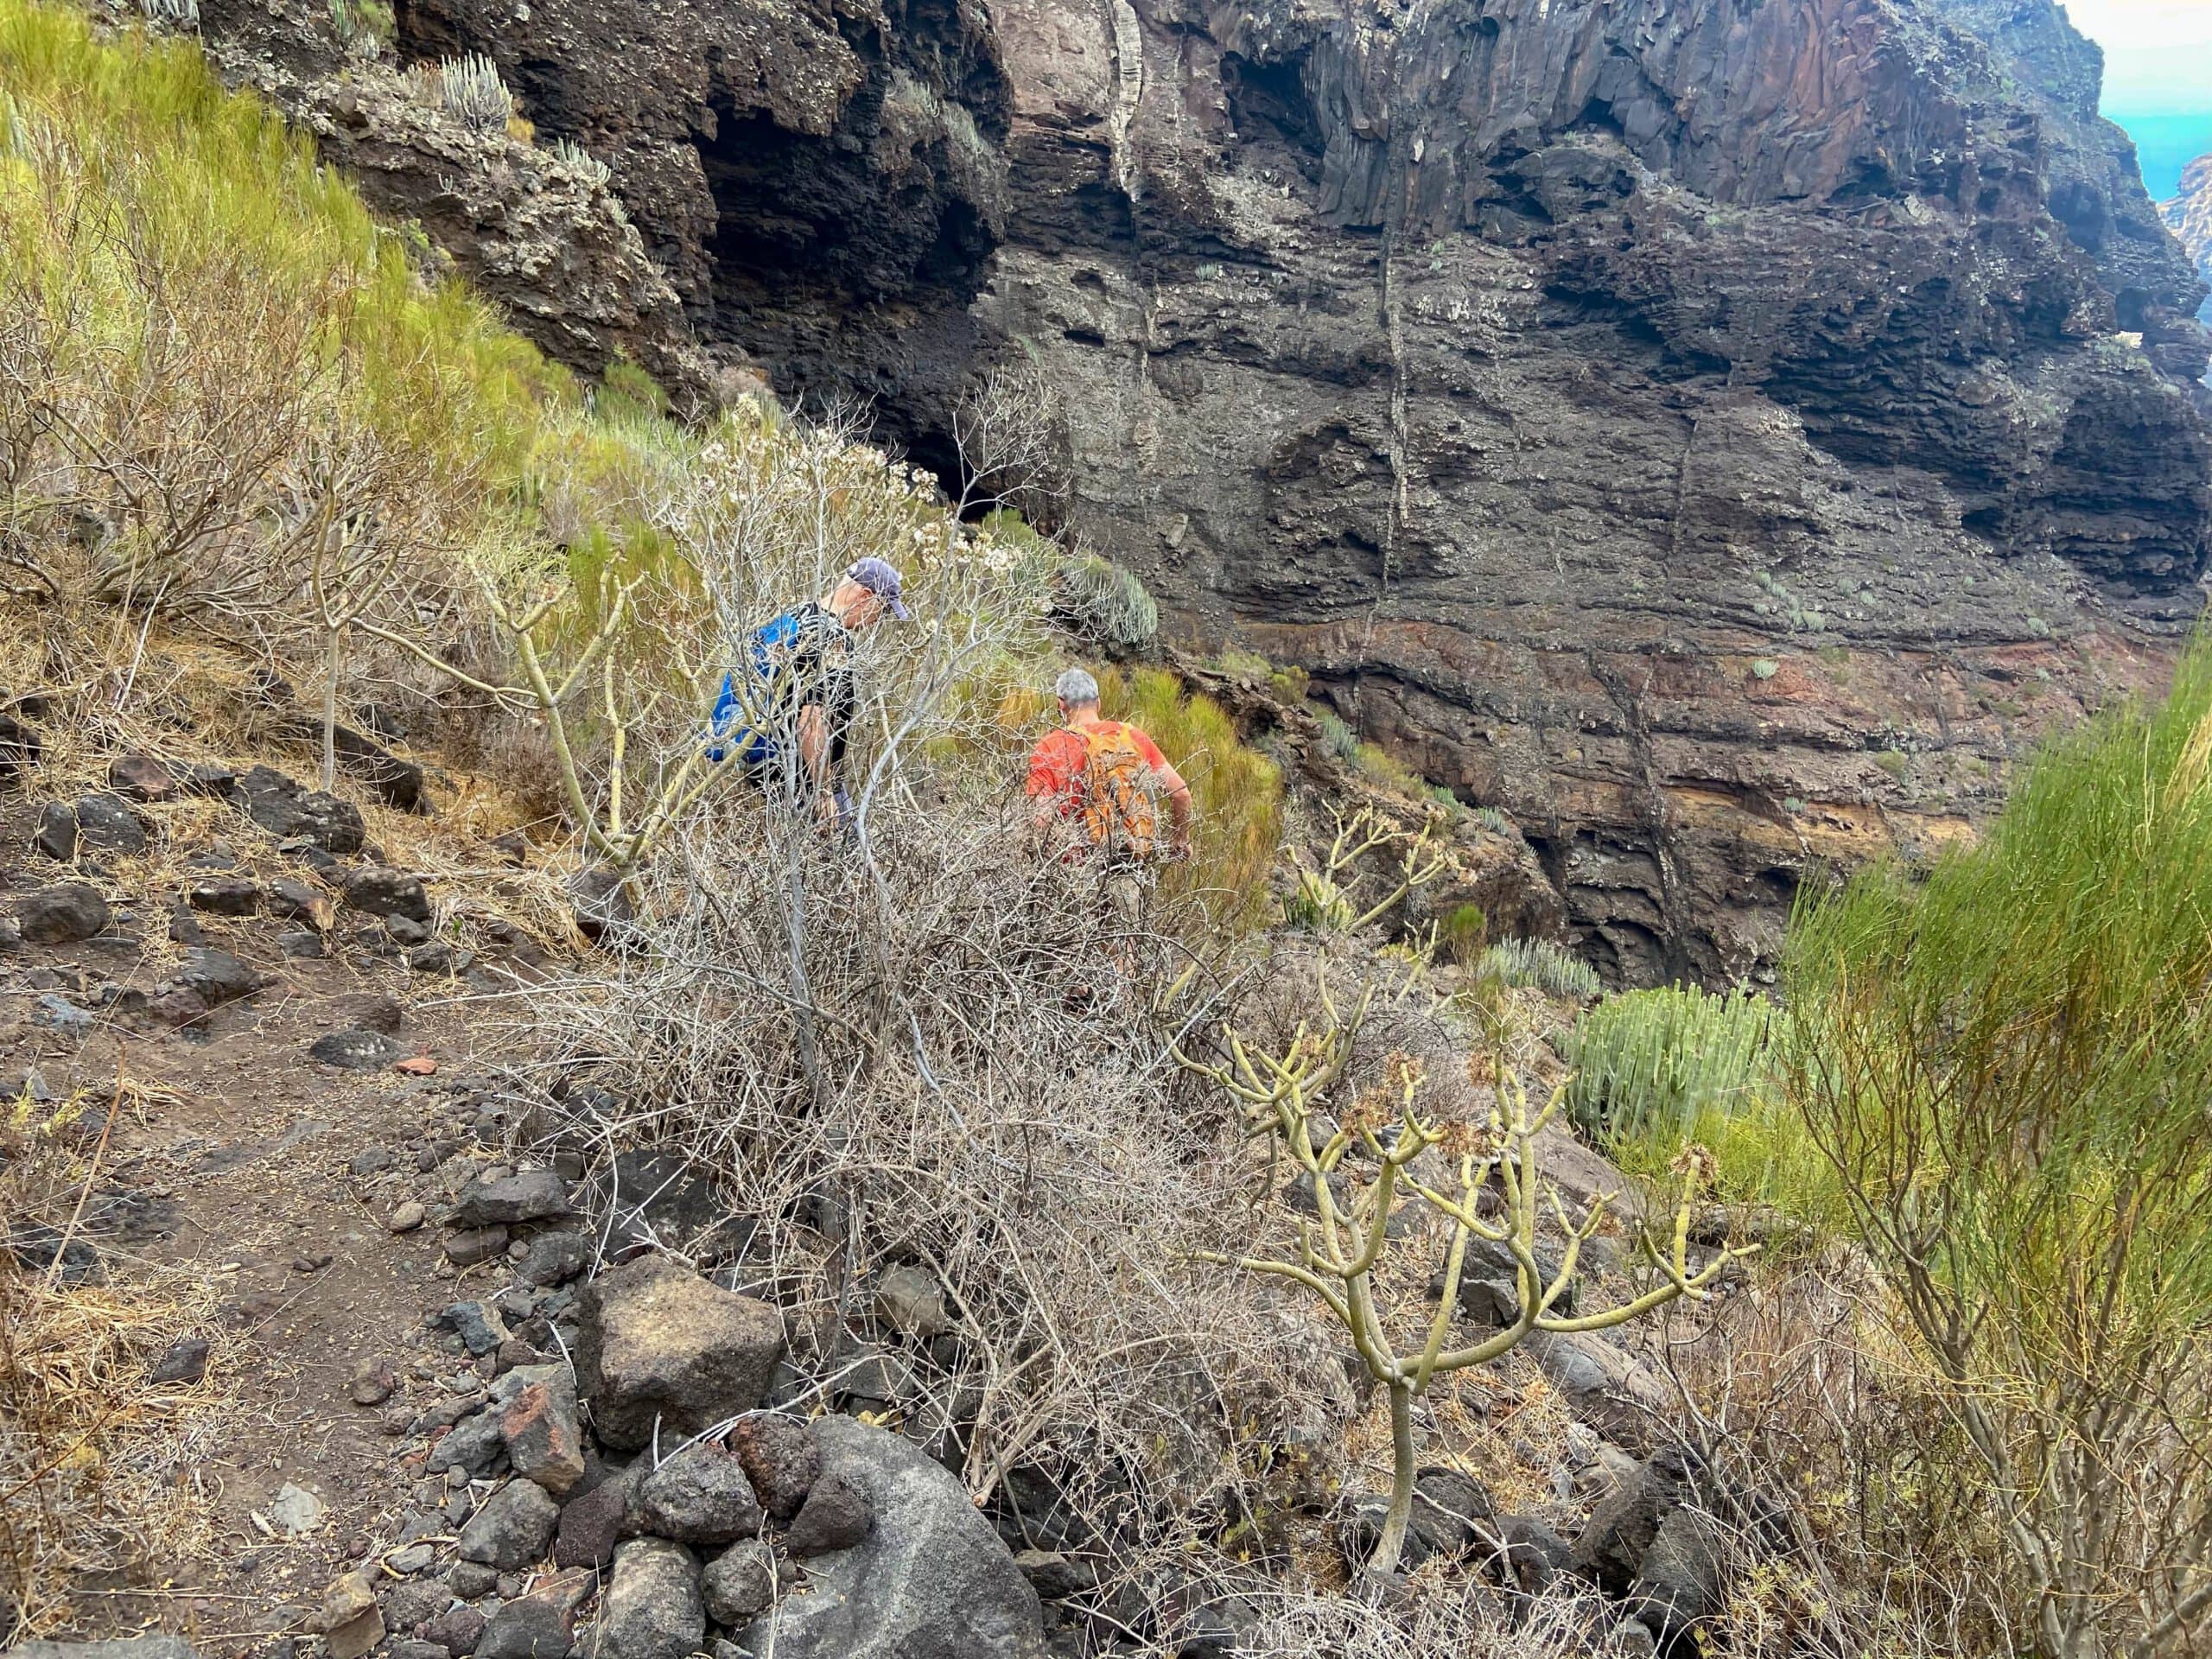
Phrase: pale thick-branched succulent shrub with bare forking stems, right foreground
[{"left": 1177, "top": 964, "right": 1757, "bottom": 1584}]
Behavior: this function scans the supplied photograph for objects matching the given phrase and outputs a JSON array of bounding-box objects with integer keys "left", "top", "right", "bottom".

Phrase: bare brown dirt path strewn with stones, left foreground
[{"left": 0, "top": 814, "right": 542, "bottom": 1652}]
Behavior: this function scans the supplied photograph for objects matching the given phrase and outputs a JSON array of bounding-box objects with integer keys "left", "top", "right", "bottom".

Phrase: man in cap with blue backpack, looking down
[{"left": 706, "top": 557, "right": 912, "bottom": 830}]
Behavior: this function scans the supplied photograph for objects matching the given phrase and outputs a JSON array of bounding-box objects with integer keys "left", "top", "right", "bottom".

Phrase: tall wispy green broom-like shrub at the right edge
[{"left": 1785, "top": 637, "right": 2212, "bottom": 1655}]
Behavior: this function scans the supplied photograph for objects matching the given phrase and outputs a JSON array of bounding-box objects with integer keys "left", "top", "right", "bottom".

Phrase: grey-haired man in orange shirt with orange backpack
[{"left": 1027, "top": 668, "right": 1190, "bottom": 923}]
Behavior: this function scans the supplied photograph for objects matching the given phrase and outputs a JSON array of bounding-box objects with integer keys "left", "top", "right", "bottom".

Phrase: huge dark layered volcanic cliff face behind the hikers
[{"left": 194, "top": 0, "right": 2212, "bottom": 980}]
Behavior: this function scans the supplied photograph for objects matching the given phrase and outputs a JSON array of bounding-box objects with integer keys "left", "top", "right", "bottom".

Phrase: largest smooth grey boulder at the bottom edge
[{"left": 739, "top": 1418, "right": 1044, "bottom": 1659}]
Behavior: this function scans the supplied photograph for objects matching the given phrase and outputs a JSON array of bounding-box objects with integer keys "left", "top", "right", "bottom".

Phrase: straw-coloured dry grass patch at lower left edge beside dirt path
[{"left": 0, "top": 1079, "right": 237, "bottom": 1637}]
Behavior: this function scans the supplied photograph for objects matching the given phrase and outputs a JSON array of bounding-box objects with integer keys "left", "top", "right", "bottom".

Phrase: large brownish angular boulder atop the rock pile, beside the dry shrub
[{"left": 575, "top": 1256, "right": 783, "bottom": 1451}]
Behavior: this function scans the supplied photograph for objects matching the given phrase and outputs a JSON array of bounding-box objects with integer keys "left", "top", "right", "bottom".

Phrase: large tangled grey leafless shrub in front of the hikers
[{"left": 508, "top": 781, "right": 1344, "bottom": 1583}]
